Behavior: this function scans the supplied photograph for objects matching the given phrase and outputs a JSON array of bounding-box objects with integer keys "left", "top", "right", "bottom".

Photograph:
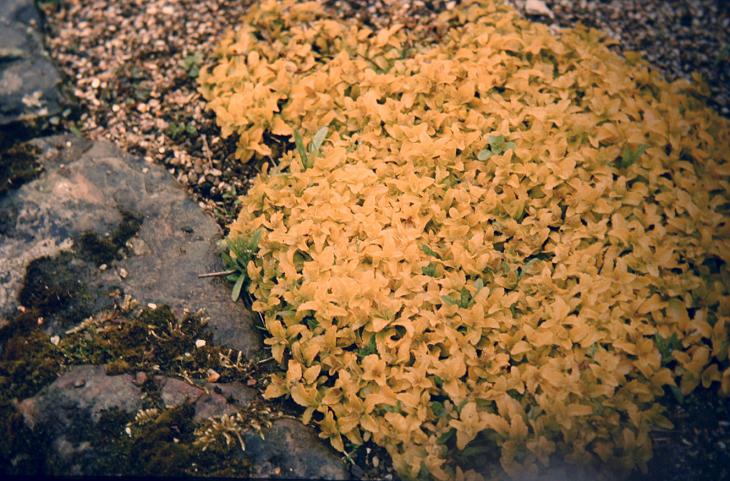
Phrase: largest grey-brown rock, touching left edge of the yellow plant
[{"left": 0, "top": 136, "right": 262, "bottom": 356}]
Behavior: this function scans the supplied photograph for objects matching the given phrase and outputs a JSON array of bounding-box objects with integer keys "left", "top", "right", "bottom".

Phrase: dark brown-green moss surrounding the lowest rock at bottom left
[{"left": 0, "top": 306, "right": 260, "bottom": 476}]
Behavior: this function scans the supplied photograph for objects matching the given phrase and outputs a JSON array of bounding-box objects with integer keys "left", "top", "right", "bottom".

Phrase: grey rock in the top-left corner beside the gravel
[{"left": 0, "top": 0, "right": 62, "bottom": 133}]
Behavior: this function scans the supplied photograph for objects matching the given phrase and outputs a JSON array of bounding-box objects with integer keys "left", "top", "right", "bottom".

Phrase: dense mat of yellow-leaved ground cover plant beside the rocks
[{"left": 199, "top": 0, "right": 730, "bottom": 479}]
